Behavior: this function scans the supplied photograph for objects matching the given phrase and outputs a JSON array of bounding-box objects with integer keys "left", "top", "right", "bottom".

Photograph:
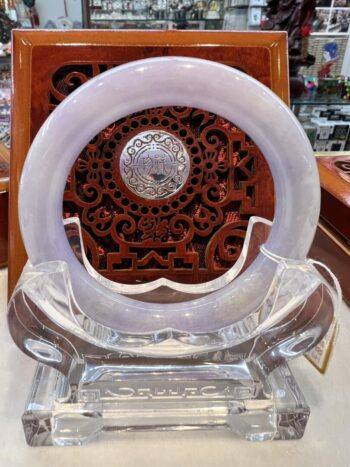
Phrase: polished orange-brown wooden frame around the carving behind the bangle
[{"left": 9, "top": 31, "right": 289, "bottom": 292}]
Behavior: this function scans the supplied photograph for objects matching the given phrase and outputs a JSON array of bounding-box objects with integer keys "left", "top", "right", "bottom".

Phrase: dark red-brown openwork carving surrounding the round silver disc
[{"left": 50, "top": 65, "right": 273, "bottom": 283}]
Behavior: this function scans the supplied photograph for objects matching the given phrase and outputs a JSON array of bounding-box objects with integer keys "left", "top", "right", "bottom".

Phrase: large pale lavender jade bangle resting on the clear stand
[{"left": 19, "top": 57, "right": 320, "bottom": 334}]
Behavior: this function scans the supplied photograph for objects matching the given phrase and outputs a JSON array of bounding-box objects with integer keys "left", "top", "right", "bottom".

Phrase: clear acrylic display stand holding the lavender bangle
[{"left": 9, "top": 217, "right": 340, "bottom": 446}]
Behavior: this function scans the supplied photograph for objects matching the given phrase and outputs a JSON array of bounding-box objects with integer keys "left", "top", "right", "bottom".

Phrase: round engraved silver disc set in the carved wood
[{"left": 120, "top": 130, "right": 190, "bottom": 199}]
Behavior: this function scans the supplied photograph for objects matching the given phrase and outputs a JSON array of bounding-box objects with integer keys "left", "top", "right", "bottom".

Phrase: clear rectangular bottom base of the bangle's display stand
[{"left": 22, "top": 359, "right": 310, "bottom": 446}]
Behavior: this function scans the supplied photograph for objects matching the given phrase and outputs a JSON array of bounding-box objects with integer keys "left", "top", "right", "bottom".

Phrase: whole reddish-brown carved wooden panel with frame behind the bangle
[{"left": 10, "top": 31, "right": 288, "bottom": 290}]
